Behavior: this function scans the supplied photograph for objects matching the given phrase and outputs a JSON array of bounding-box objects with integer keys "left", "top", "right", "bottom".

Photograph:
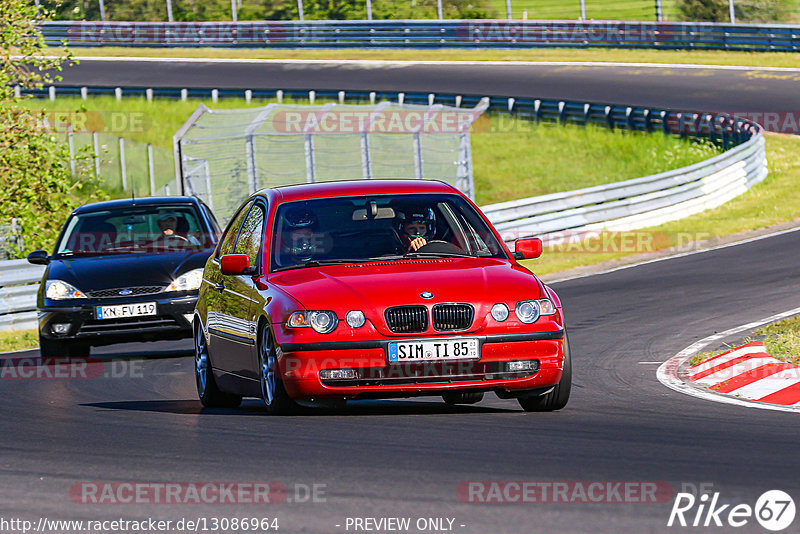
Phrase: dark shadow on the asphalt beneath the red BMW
[{"left": 81, "top": 399, "right": 519, "bottom": 417}]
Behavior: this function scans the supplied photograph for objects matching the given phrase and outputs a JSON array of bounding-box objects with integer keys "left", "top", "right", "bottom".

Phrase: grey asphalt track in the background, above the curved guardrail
[{"left": 54, "top": 58, "right": 800, "bottom": 116}]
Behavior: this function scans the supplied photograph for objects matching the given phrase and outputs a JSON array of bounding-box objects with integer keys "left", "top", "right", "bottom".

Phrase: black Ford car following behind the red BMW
[{"left": 28, "top": 197, "right": 220, "bottom": 357}]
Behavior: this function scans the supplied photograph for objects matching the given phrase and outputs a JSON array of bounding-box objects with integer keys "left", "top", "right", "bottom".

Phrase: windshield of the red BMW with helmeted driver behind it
[{"left": 270, "top": 194, "right": 506, "bottom": 271}]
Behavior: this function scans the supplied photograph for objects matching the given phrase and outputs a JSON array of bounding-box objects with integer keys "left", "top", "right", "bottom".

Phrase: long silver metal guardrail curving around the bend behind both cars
[{"left": 9, "top": 87, "right": 767, "bottom": 330}]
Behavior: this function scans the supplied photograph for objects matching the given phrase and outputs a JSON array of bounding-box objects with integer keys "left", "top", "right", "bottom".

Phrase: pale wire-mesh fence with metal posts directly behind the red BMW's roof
[{"left": 175, "top": 99, "right": 489, "bottom": 220}]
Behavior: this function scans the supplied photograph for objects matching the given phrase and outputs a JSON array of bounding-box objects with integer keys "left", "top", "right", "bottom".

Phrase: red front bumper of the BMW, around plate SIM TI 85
[{"left": 278, "top": 330, "right": 564, "bottom": 399}]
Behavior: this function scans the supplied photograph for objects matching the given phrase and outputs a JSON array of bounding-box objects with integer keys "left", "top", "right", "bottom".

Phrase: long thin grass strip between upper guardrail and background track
[{"left": 56, "top": 47, "right": 800, "bottom": 67}]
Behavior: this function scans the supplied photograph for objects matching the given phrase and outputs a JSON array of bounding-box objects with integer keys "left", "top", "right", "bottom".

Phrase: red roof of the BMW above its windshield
[{"left": 263, "top": 180, "right": 457, "bottom": 202}]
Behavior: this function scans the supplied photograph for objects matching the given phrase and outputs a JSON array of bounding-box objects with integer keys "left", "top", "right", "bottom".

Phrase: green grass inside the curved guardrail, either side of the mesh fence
[{"left": 21, "top": 97, "right": 719, "bottom": 204}]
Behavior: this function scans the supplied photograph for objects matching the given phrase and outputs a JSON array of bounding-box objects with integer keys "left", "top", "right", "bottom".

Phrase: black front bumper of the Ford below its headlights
[{"left": 38, "top": 293, "right": 197, "bottom": 346}]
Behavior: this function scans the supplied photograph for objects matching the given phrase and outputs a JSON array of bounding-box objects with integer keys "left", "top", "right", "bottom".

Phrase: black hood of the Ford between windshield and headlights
[{"left": 47, "top": 249, "right": 212, "bottom": 291}]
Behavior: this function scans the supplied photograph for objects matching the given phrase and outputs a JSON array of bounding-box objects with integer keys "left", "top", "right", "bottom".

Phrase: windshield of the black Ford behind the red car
[{"left": 56, "top": 205, "right": 214, "bottom": 255}]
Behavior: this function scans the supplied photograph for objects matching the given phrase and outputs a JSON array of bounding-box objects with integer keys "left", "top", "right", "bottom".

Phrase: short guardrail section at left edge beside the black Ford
[{"left": 0, "top": 260, "right": 45, "bottom": 331}]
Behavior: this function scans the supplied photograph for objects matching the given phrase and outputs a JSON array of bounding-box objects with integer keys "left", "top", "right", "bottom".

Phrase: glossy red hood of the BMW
[{"left": 270, "top": 258, "right": 542, "bottom": 336}]
